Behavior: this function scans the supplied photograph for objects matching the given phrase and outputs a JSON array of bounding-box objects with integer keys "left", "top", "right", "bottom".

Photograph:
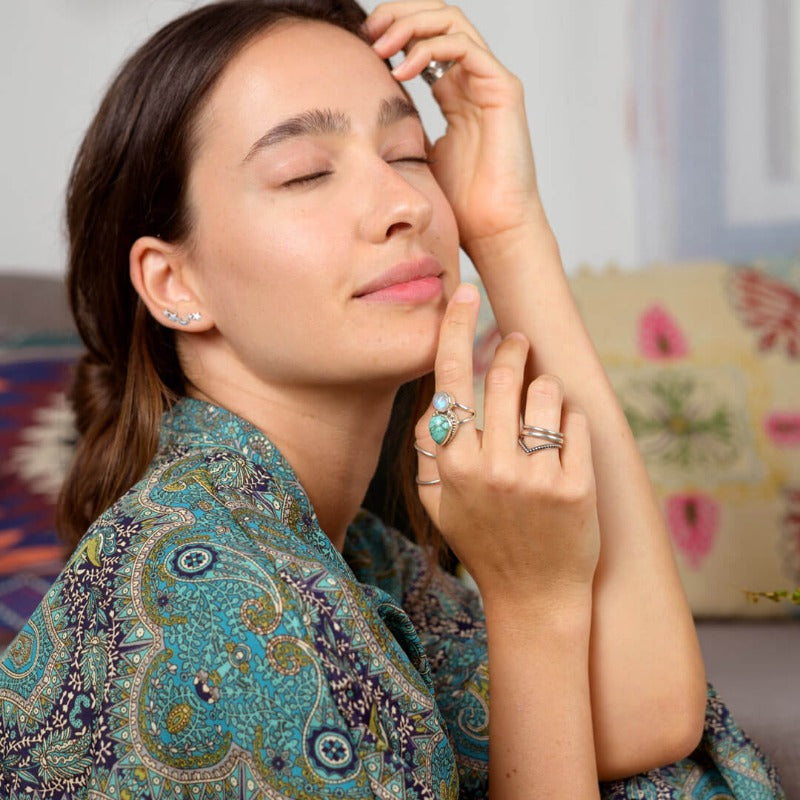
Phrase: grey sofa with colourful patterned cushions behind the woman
[{"left": 0, "top": 270, "right": 800, "bottom": 799}]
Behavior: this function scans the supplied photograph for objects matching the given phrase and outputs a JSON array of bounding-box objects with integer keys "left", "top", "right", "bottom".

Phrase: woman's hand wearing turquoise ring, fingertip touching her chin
[{"left": 416, "top": 284, "right": 600, "bottom": 609}]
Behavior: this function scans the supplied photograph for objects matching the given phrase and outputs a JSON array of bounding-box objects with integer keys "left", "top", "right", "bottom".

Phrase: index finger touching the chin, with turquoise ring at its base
[{"left": 434, "top": 283, "right": 480, "bottom": 456}]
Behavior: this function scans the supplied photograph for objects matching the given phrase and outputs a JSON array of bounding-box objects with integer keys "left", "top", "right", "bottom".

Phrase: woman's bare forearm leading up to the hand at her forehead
[{"left": 469, "top": 222, "right": 705, "bottom": 777}]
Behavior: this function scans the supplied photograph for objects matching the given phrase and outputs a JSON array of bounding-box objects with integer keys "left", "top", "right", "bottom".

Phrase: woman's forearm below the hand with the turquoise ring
[{"left": 485, "top": 591, "right": 598, "bottom": 800}]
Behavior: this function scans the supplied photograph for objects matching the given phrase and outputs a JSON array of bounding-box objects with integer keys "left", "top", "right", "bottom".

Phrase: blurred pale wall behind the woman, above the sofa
[{"left": 0, "top": 0, "right": 800, "bottom": 274}]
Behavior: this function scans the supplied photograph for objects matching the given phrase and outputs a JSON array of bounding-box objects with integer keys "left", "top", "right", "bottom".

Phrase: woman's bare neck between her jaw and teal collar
[{"left": 190, "top": 376, "right": 395, "bottom": 551}]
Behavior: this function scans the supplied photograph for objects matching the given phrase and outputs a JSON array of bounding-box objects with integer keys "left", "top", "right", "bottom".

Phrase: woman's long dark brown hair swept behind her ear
[{"left": 57, "top": 0, "right": 440, "bottom": 564}]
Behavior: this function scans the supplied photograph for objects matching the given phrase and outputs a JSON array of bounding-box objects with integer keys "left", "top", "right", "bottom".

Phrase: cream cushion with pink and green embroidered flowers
[{"left": 476, "top": 262, "right": 800, "bottom": 617}]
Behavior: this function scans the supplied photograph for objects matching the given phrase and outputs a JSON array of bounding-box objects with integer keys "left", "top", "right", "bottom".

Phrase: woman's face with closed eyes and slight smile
[{"left": 180, "top": 20, "right": 458, "bottom": 394}]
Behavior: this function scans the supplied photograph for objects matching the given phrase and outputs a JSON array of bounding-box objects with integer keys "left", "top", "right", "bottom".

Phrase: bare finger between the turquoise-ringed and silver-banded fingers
[{"left": 482, "top": 333, "right": 529, "bottom": 460}]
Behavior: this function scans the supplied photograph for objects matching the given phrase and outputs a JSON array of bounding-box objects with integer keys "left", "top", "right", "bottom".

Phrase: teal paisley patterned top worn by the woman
[{"left": 0, "top": 399, "right": 783, "bottom": 800}]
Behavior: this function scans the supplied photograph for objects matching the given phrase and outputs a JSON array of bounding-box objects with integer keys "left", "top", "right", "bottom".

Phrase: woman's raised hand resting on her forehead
[{"left": 365, "top": 0, "right": 546, "bottom": 252}]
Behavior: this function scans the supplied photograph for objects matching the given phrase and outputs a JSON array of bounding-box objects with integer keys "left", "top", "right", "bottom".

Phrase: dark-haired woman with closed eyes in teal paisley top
[{"left": 0, "top": 0, "right": 781, "bottom": 800}]
